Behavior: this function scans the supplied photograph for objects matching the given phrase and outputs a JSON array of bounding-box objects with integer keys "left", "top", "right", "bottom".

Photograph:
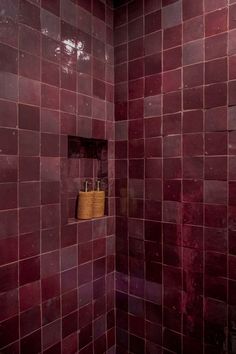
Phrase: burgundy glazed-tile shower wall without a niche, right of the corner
[{"left": 114, "top": 0, "right": 236, "bottom": 354}]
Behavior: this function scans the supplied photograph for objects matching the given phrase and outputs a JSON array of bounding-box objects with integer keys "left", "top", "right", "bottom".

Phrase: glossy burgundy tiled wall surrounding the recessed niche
[{"left": 0, "top": 0, "right": 115, "bottom": 354}]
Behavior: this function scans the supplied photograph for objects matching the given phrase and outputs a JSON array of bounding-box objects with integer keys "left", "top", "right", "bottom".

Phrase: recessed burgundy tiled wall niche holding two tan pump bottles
[{"left": 67, "top": 136, "right": 108, "bottom": 222}]
